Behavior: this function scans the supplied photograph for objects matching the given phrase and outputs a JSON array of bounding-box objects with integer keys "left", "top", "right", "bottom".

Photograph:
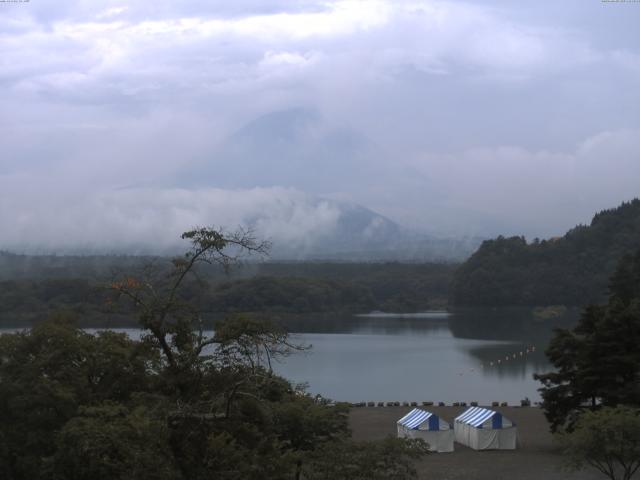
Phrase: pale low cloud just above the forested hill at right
[{"left": 400, "top": 130, "right": 640, "bottom": 236}]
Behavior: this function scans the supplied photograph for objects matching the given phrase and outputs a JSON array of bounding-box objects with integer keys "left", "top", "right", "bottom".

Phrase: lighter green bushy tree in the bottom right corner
[{"left": 558, "top": 407, "right": 640, "bottom": 480}]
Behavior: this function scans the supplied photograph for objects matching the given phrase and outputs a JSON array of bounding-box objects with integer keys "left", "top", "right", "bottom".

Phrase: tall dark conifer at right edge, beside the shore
[{"left": 536, "top": 251, "right": 640, "bottom": 430}]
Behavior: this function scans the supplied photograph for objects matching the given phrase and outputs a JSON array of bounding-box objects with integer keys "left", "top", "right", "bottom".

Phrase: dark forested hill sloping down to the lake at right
[{"left": 451, "top": 199, "right": 640, "bottom": 306}]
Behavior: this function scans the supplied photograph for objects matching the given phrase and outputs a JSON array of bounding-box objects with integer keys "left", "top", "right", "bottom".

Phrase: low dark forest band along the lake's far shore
[{"left": 0, "top": 255, "right": 454, "bottom": 327}]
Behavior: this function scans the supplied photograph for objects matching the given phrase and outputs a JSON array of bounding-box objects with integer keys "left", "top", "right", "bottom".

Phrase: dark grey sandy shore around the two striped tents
[{"left": 350, "top": 407, "right": 603, "bottom": 480}]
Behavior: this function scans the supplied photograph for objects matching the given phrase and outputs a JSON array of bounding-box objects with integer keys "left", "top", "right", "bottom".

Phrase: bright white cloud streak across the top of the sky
[{"left": 0, "top": 0, "right": 608, "bottom": 101}]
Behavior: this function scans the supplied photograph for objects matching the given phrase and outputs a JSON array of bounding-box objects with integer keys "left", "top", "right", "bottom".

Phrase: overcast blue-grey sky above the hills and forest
[{"left": 0, "top": 0, "right": 640, "bottom": 253}]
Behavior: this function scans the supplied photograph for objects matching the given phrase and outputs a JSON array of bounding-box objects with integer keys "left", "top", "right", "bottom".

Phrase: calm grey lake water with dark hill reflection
[{"left": 5, "top": 308, "right": 575, "bottom": 404}]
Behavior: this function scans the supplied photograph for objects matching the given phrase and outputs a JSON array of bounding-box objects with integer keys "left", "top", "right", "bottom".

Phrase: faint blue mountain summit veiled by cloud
[{"left": 182, "top": 108, "right": 384, "bottom": 195}]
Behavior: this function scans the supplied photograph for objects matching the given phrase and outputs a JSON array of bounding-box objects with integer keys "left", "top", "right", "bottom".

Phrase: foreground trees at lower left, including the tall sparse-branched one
[{"left": 0, "top": 229, "right": 427, "bottom": 480}]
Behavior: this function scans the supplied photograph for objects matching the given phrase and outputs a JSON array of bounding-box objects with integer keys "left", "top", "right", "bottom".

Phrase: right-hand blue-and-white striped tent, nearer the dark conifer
[{"left": 454, "top": 407, "right": 517, "bottom": 450}]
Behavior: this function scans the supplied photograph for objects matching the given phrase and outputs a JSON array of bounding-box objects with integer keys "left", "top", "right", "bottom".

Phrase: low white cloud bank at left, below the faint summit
[{"left": 0, "top": 183, "right": 340, "bottom": 253}]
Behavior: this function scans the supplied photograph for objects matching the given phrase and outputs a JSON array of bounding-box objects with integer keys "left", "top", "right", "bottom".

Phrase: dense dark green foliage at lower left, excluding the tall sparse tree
[{"left": 0, "top": 318, "right": 384, "bottom": 480}]
